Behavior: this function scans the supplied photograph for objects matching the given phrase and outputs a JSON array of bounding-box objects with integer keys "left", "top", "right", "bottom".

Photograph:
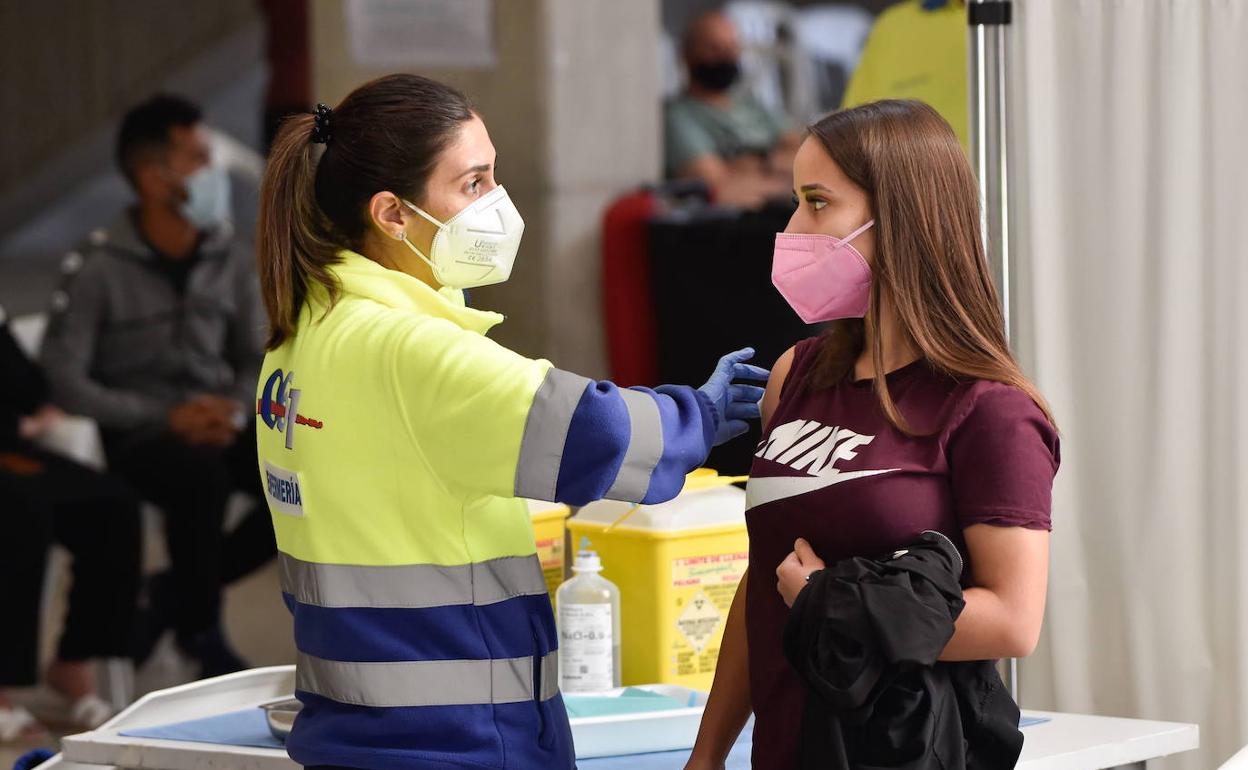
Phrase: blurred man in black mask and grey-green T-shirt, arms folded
[{"left": 664, "top": 11, "right": 801, "bottom": 207}]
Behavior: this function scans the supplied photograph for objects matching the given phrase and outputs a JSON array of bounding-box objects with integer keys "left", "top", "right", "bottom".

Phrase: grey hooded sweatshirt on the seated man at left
[{"left": 41, "top": 213, "right": 265, "bottom": 433}]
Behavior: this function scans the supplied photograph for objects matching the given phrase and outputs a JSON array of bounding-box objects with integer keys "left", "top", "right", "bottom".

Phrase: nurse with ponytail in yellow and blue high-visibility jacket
[{"left": 257, "top": 75, "right": 766, "bottom": 770}]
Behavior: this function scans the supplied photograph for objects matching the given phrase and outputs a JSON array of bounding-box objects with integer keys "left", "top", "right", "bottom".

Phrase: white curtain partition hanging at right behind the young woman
[{"left": 1011, "top": 0, "right": 1248, "bottom": 770}]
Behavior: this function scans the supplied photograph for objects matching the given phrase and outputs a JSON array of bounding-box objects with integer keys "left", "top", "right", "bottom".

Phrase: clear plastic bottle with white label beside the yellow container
[{"left": 555, "top": 538, "right": 620, "bottom": 693}]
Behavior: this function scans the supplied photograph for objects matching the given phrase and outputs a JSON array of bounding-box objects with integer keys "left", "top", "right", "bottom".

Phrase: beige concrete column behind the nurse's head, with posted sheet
[{"left": 312, "top": 0, "right": 661, "bottom": 377}]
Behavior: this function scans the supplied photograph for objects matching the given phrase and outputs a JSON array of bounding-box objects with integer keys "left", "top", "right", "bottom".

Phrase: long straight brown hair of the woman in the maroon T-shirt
[{"left": 805, "top": 100, "right": 1056, "bottom": 436}]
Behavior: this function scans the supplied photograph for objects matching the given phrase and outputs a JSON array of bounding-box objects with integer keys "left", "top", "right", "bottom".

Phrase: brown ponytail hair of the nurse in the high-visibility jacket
[{"left": 256, "top": 75, "right": 474, "bottom": 349}]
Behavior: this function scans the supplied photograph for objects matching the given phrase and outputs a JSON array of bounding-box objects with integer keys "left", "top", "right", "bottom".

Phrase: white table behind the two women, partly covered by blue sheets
[{"left": 39, "top": 666, "right": 1199, "bottom": 770}]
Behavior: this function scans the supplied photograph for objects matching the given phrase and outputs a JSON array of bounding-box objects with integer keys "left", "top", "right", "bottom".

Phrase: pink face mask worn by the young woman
[{"left": 771, "top": 220, "right": 875, "bottom": 323}]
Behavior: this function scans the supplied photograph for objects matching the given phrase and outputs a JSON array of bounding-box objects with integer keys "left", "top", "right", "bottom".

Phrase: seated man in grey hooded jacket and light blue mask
[{"left": 42, "top": 95, "right": 275, "bottom": 676}]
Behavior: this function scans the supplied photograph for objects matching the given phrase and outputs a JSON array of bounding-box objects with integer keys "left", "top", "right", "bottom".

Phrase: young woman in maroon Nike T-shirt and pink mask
[{"left": 689, "top": 101, "right": 1058, "bottom": 770}]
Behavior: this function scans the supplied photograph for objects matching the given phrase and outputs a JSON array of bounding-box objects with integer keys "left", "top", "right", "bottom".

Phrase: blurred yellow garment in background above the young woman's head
[{"left": 841, "top": 0, "right": 971, "bottom": 152}]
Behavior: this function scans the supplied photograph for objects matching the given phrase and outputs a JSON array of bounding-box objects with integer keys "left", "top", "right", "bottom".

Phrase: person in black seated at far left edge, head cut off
[{"left": 0, "top": 303, "right": 141, "bottom": 745}]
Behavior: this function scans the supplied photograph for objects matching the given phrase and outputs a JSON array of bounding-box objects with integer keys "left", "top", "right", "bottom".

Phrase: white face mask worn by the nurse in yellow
[{"left": 399, "top": 185, "right": 524, "bottom": 288}]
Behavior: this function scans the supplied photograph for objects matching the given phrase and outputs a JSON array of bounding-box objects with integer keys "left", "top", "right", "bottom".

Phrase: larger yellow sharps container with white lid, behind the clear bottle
[{"left": 568, "top": 469, "right": 749, "bottom": 690}]
